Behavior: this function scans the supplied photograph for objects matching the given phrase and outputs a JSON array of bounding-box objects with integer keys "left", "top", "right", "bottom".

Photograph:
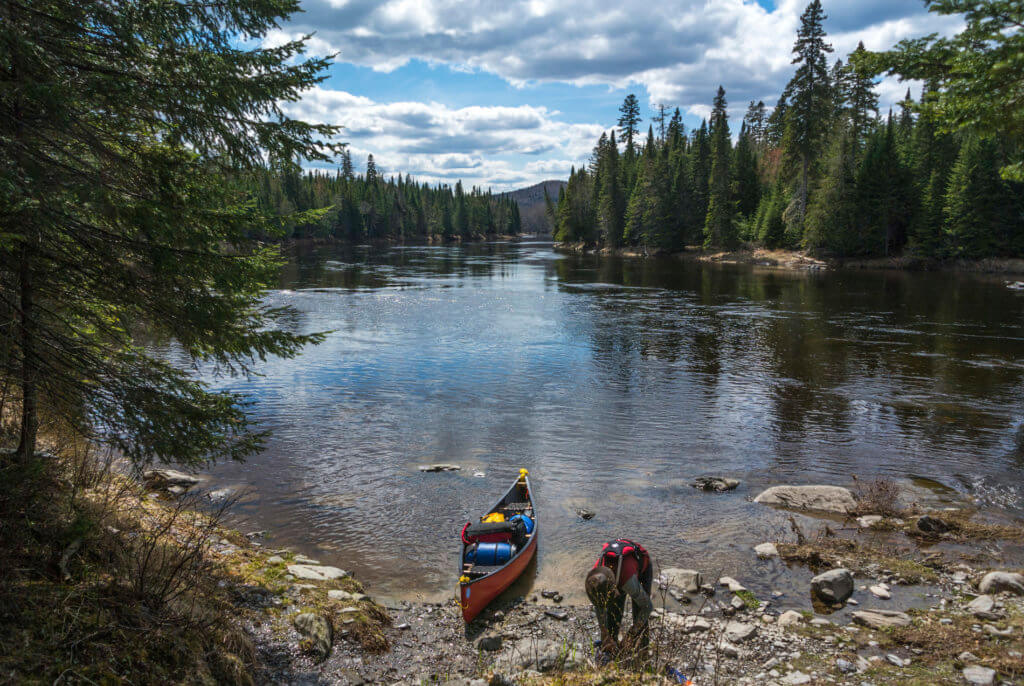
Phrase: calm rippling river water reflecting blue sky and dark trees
[{"left": 197, "top": 243, "right": 1024, "bottom": 599}]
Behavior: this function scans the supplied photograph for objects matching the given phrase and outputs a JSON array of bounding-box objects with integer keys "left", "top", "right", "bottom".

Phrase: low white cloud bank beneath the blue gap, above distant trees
[{"left": 283, "top": 87, "right": 602, "bottom": 190}]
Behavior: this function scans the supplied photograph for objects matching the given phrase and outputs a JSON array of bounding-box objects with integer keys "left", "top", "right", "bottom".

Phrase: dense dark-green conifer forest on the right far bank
[{"left": 555, "top": 0, "right": 1024, "bottom": 258}]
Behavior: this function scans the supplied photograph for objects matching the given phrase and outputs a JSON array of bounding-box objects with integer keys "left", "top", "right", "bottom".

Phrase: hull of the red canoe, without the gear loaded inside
[{"left": 459, "top": 469, "right": 540, "bottom": 623}]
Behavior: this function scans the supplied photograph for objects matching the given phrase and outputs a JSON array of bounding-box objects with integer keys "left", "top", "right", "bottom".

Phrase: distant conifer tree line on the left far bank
[{"left": 250, "top": 151, "right": 522, "bottom": 243}]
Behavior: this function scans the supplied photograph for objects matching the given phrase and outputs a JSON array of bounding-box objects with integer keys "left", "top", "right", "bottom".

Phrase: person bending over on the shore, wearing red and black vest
[{"left": 584, "top": 539, "right": 654, "bottom": 667}]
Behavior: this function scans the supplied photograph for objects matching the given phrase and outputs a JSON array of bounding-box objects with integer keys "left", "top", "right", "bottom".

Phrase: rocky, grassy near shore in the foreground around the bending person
[{"left": 8, "top": 444, "right": 1024, "bottom": 686}]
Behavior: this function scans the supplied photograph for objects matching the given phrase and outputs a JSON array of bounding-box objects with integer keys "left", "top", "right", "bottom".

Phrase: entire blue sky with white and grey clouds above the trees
[{"left": 263, "top": 0, "right": 958, "bottom": 191}]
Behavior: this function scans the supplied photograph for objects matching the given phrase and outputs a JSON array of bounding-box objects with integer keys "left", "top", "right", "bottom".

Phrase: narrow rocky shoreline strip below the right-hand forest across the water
[{"left": 555, "top": 244, "right": 1024, "bottom": 274}]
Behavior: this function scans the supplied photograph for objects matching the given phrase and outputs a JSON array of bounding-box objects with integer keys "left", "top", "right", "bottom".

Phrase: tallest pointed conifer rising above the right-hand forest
[{"left": 783, "top": 0, "right": 833, "bottom": 230}]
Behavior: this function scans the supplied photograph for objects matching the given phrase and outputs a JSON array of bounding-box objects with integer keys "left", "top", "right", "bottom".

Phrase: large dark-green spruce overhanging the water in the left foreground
[{"left": 0, "top": 0, "right": 339, "bottom": 464}]
